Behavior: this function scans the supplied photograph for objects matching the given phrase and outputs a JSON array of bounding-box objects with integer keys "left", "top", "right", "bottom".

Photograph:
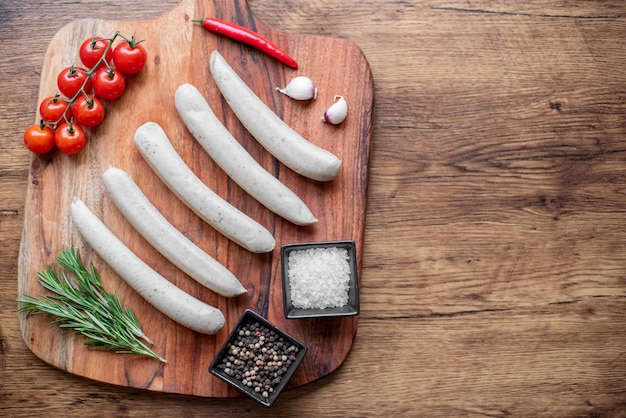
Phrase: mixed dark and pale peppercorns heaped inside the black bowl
[{"left": 217, "top": 321, "right": 299, "bottom": 398}]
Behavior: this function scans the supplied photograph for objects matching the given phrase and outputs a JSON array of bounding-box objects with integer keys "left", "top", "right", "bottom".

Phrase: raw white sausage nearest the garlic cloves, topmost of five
[{"left": 210, "top": 51, "right": 341, "bottom": 181}]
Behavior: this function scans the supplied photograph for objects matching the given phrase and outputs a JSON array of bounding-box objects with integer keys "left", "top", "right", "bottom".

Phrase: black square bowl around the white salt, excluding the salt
[{"left": 280, "top": 240, "right": 360, "bottom": 319}]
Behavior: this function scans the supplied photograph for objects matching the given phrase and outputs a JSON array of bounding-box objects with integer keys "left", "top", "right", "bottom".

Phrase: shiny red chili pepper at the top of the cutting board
[{"left": 193, "top": 17, "right": 298, "bottom": 68}]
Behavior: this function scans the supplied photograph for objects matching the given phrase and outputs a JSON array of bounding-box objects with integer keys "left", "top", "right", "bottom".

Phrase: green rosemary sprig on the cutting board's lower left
[{"left": 18, "top": 247, "right": 166, "bottom": 363}]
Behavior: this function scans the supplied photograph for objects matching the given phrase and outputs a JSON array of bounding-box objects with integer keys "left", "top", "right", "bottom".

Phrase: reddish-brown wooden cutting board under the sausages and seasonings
[{"left": 18, "top": 0, "right": 374, "bottom": 397}]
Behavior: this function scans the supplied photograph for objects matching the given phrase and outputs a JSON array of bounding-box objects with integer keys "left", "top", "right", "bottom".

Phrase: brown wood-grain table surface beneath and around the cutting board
[{"left": 0, "top": 0, "right": 626, "bottom": 417}]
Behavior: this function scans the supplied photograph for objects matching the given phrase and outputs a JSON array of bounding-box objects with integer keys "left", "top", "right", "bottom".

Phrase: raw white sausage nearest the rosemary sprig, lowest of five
[{"left": 70, "top": 198, "right": 226, "bottom": 334}]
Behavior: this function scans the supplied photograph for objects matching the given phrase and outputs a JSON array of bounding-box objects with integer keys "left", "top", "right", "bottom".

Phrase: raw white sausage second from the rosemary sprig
[{"left": 102, "top": 167, "right": 246, "bottom": 297}]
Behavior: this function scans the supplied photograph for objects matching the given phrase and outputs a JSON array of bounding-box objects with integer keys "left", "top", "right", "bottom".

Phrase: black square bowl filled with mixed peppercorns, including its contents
[{"left": 209, "top": 309, "right": 307, "bottom": 407}]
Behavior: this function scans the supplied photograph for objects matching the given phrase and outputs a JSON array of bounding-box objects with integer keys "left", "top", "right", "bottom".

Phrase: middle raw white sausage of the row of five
[{"left": 135, "top": 122, "right": 276, "bottom": 253}]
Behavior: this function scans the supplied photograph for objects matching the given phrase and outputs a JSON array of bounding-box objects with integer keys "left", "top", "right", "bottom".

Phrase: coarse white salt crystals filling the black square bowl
[{"left": 287, "top": 247, "right": 350, "bottom": 309}]
